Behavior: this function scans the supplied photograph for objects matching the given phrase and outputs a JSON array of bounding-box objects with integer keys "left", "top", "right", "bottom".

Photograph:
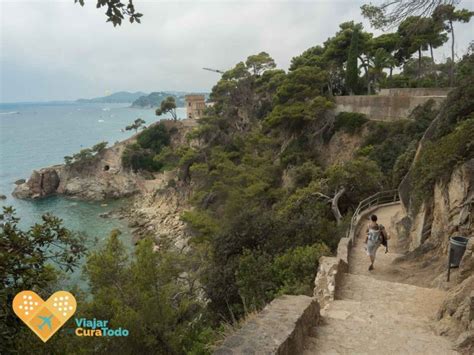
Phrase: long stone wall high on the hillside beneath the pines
[{"left": 335, "top": 95, "right": 446, "bottom": 121}]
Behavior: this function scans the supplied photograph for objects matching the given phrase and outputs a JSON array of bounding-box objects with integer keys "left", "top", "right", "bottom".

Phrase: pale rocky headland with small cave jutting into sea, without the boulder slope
[{"left": 12, "top": 120, "right": 196, "bottom": 201}]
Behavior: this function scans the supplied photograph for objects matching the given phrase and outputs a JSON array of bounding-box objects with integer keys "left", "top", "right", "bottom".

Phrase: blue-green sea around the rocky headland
[{"left": 0, "top": 102, "right": 185, "bottom": 283}]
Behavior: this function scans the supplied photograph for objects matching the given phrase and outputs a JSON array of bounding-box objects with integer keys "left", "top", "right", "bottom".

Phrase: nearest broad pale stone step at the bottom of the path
[{"left": 303, "top": 300, "right": 457, "bottom": 355}]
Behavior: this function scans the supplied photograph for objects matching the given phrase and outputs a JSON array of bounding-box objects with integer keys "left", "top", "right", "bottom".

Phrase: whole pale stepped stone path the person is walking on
[{"left": 304, "top": 204, "right": 457, "bottom": 355}]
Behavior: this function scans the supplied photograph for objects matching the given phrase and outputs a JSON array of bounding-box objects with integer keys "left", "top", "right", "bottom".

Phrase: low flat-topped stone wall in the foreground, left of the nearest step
[{"left": 214, "top": 295, "right": 319, "bottom": 355}]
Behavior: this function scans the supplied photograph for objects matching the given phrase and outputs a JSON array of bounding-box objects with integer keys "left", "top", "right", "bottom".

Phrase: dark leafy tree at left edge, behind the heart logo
[{"left": 0, "top": 207, "right": 86, "bottom": 354}]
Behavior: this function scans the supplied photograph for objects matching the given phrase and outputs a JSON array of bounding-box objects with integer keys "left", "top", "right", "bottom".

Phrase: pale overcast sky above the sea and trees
[{"left": 0, "top": 0, "right": 474, "bottom": 102}]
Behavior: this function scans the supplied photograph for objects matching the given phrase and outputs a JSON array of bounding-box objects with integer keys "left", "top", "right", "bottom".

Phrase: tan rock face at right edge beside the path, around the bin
[{"left": 398, "top": 159, "right": 474, "bottom": 352}]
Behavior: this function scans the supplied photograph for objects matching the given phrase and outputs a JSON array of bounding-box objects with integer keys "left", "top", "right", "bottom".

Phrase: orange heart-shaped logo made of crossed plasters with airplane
[{"left": 13, "top": 291, "right": 77, "bottom": 343}]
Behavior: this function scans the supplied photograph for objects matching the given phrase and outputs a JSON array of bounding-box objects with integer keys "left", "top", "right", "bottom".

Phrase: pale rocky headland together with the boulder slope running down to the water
[{"left": 12, "top": 120, "right": 200, "bottom": 251}]
